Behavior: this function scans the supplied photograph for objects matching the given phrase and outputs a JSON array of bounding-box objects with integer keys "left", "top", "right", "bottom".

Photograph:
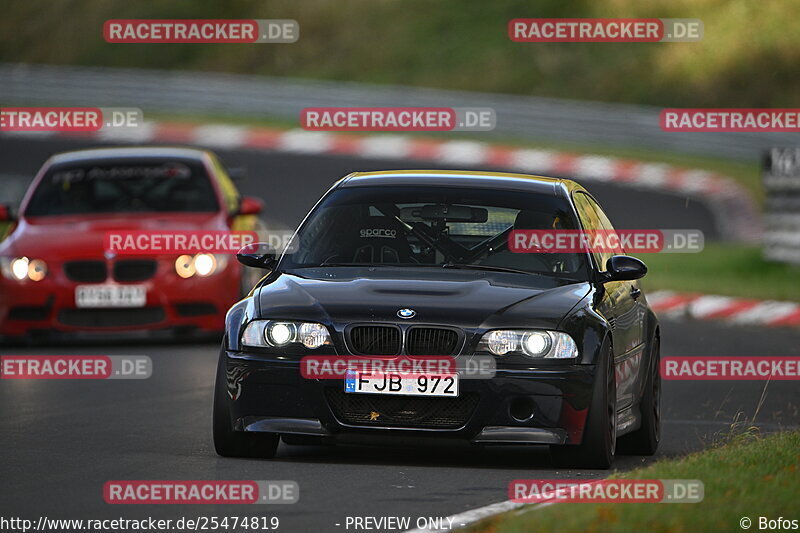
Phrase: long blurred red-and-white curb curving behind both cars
[{"left": 5, "top": 122, "right": 761, "bottom": 241}]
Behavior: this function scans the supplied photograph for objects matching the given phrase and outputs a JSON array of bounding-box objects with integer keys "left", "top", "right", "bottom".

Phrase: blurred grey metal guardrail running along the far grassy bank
[{"left": 0, "top": 63, "right": 797, "bottom": 160}]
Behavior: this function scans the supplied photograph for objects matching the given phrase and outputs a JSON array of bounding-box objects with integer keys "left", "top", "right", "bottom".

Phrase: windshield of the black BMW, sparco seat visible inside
[{"left": 280, "top": 186, "right": 588, "bottom": 280}]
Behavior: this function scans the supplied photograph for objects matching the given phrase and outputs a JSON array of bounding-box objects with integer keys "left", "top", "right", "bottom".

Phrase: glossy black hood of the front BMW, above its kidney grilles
[{"left": 257, "top": 267, "right": 591, "bottom": 328}]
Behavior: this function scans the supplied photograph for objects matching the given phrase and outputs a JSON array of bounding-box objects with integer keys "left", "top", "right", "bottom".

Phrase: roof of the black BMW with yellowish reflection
[{"left": 339, "top": 170, "right": 583, "bottom": 196}]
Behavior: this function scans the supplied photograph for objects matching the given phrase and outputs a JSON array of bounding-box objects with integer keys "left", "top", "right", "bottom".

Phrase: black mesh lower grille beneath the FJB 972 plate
[{"left": 325, "top": 388, "right": 478, "bottom": 429}]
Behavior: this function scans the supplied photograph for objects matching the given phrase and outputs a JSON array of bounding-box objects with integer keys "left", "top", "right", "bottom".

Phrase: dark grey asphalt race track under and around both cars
[{"left": 0, "top": 138, "right": 800, "bottom": 532}]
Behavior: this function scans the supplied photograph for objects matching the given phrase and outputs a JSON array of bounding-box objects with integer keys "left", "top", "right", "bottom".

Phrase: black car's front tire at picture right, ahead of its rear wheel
[{"left": 550, "top": 341, "right": 617, "bottom": 469}]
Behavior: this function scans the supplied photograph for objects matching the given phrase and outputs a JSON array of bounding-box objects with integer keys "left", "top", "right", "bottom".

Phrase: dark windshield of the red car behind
[{"left": 24, "top": 159, "right": 219, "bottom": 217}]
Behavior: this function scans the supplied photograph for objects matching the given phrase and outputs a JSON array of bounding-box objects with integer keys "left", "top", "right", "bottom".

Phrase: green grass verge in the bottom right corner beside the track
[{"left": 468, "top": 431, "right": 800, "bottom": 533}]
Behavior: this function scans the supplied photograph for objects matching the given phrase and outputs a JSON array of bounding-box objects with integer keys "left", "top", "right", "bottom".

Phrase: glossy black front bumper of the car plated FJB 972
[{"left": 224, "top": 351, "right": 595, "bottom": 444}]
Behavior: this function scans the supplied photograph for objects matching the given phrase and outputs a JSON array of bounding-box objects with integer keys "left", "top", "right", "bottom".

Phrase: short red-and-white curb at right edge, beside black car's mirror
[{"left": 647, "top": 291, "right": 800, "bottom": 326}]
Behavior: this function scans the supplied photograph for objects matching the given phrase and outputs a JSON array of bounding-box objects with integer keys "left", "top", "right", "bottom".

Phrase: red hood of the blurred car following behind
[{"left": 0, "top": 213, "right": 228, "bottom": 261}]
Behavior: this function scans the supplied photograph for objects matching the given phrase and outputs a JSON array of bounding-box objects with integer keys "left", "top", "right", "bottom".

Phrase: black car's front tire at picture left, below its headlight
[{"left": 212, "top": 342, "right": 279, "bottom": 459}]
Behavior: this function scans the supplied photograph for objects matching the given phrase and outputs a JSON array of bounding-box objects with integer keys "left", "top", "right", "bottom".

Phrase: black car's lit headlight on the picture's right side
[{"left": 478, "top": 329, "right": 578, "bottom": 359}]
